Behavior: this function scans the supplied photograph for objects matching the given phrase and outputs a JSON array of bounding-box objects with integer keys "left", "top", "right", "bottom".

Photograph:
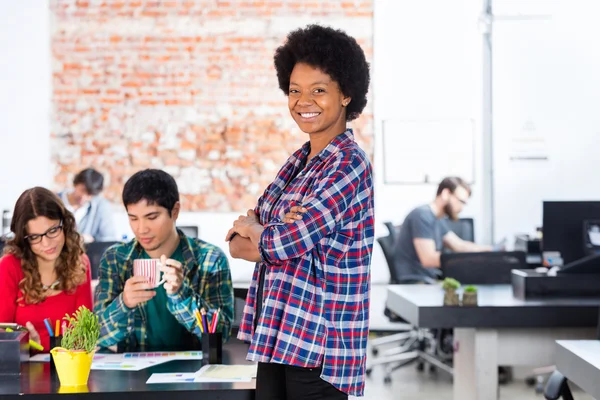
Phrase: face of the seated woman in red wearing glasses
[{"left": 26, "top": 217, "right": 65, "bottom": 262}]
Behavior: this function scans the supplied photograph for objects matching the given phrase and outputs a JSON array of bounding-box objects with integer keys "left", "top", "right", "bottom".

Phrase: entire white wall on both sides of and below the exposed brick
[{"left": 10, "top": 0, "right": 600, "bottom": 288}]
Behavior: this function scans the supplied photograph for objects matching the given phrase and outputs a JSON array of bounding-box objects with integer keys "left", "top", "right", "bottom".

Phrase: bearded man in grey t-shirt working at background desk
[{"left": 396, "top": 177, "right": 492, "bottom": 278}]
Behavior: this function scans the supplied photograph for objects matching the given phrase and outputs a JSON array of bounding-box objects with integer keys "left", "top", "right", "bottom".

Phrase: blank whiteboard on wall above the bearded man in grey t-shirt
[{"left": 382, "top": 118, "right": 475, "bottom": 184}]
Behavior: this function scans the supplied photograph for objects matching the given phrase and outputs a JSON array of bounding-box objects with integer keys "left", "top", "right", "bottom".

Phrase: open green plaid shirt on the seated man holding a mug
[{"left": 94, "top": 231, "right": 233, "bottom": 348}]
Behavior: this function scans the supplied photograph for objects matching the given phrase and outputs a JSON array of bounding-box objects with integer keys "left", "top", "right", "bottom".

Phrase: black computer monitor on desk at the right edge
[{"left": 542, "top": 201, "right": 600, "bottom": 265}]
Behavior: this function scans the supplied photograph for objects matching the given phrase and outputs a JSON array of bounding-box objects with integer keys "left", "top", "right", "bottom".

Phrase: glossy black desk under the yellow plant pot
[{"left": 0, "top": 338, "right": 256, "bottom": 400}]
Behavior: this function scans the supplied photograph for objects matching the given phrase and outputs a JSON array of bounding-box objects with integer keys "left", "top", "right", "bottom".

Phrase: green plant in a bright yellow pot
[{"left": 50, "top": 306, "right": 100, "bottom": 386}]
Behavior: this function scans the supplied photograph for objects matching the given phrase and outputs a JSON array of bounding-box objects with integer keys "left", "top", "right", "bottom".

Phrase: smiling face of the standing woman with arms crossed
[{"left": 288, "top": 63, "right": 351, "bottom": 136}]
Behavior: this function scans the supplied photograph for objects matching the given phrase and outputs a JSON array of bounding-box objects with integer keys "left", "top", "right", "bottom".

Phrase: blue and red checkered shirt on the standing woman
[{"left": 238, "top": 129, "right": 374, "bottom": 396}]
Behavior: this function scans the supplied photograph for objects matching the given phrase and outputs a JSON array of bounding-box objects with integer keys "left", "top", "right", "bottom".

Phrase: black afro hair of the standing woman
[{"left": 274, "top": 25, "right": 370, "bottom": 121}]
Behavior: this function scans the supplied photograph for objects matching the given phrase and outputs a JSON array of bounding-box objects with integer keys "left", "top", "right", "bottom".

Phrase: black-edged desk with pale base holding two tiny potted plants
[{"left": 387, "top": 285, "right": 600, "bottom": 400}]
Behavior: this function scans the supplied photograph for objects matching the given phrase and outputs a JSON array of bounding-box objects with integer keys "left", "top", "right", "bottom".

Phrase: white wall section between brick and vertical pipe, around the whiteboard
[{"left": 373, "top": 0, "right": 485, "bottom": 240}]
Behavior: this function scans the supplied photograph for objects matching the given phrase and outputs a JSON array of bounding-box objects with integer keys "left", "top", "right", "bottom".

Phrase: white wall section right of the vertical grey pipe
[{"left": 492, "top": 0, "right": 600, "bottom": 241}]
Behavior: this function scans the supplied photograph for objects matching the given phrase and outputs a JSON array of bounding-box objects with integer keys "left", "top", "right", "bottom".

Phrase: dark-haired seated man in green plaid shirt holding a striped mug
[{"left": 94, "top": 169, "right": 233, "bottom": 351}]
